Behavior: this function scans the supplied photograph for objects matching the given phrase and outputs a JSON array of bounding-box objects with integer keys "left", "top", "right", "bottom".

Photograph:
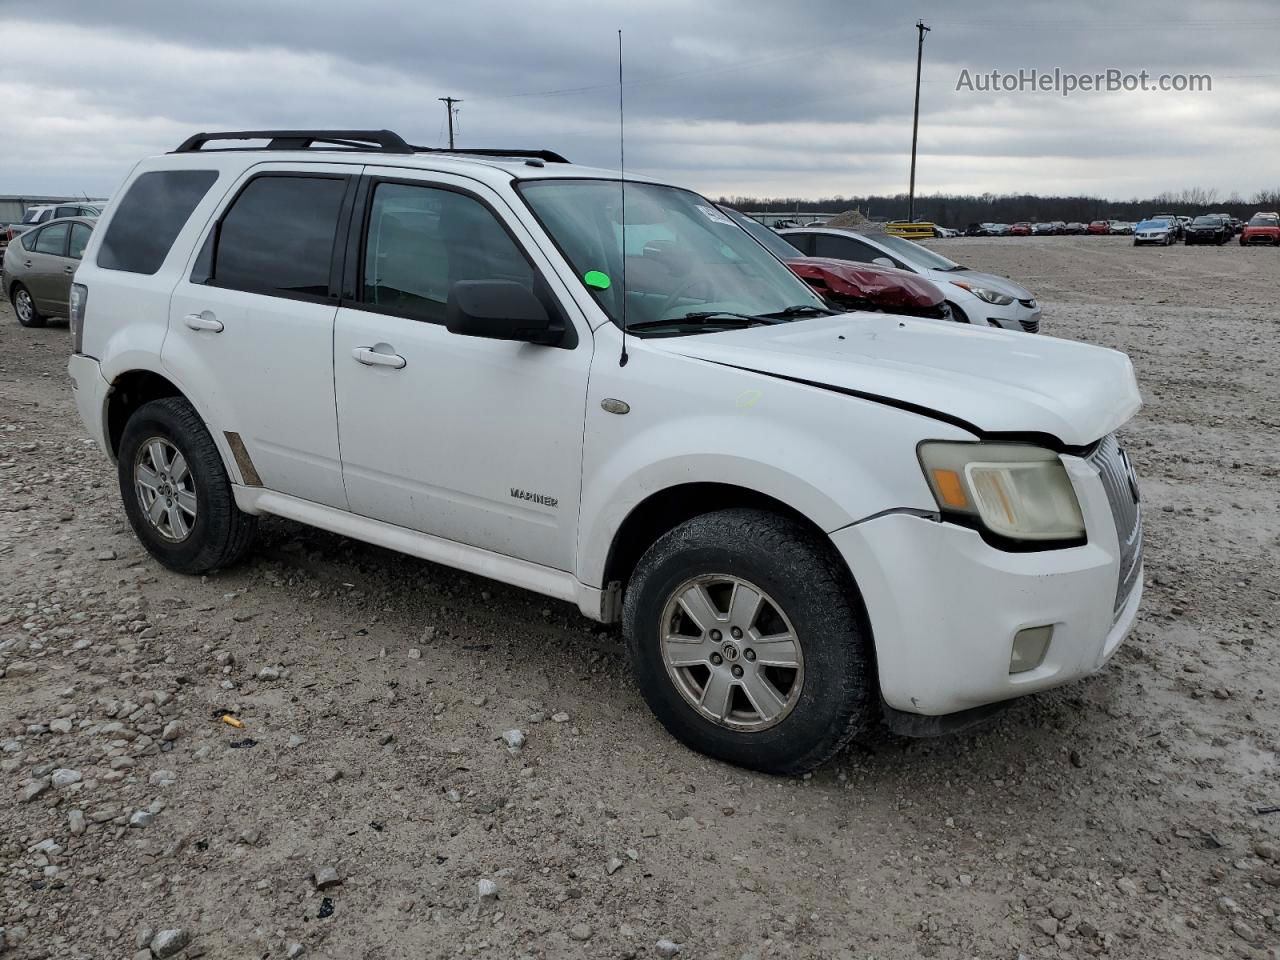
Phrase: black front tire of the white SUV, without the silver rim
[{"left": 622, "top": 508, "right": 877, "bottom": 776}]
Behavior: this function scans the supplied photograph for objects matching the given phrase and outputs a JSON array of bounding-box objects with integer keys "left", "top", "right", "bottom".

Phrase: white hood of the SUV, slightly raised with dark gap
[{"left": 646, "top": 314, "right": 1142, "bottom": 447}]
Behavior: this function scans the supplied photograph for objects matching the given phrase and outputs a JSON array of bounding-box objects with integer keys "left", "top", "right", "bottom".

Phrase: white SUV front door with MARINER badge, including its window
[{"left": 334, "top": 174, "right": 591, "bottom": 570}]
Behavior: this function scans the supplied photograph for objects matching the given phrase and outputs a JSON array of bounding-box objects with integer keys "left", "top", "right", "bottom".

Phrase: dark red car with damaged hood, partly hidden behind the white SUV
[{"left": 721, "top": 207, "right": 951, "bottom": 320}]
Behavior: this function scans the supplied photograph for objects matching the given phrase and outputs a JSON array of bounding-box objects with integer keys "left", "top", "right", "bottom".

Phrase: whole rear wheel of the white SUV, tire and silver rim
[{"left": 118, "top": 397, "right": 257, "bottom": 573}]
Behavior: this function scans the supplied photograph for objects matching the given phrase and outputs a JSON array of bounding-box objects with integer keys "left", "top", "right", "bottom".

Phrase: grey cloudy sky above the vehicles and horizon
[{"left": 0, "top": 0, "right": 1280, "bottom": 198}]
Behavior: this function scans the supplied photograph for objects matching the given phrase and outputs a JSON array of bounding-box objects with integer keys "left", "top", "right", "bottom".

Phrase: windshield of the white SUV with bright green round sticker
[{"left": 520, "top": 179, "right": 826, "bottom": 334}]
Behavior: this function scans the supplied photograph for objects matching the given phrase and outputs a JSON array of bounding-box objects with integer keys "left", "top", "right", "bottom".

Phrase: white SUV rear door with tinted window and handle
[{"left": 164, "top": 164, "right": 361, "bottom": 509}]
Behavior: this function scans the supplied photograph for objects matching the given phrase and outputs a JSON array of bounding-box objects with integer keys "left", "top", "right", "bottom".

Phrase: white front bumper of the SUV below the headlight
[{"left": 832, "top": 457, "right": 1142, "bottom": 717}]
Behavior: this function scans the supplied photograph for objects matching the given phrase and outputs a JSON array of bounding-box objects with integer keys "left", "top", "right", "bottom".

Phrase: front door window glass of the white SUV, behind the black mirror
[{"left": 361, "top": 183, "right": 534, "bottom": 323}]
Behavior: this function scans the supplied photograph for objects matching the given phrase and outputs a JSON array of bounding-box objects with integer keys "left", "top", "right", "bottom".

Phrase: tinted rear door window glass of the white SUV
[{"left": 212, "top": 177, "right": 347, "bottom": 297}]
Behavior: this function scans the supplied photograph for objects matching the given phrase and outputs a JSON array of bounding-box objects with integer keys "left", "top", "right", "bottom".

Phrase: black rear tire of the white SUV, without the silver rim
[{"left": 116, "top": 397, "right": 257, "bottom": 573}]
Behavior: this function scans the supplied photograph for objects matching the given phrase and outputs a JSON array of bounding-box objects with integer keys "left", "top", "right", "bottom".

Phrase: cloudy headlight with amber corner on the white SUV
[{"left": 919, "top": 440, "right": 1084, "bottom": 540}]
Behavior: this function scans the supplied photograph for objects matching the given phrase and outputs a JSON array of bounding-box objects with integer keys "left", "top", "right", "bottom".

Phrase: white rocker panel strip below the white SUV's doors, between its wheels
[{"left": 232, "top": 484, "right": 614, "bottom": 621}]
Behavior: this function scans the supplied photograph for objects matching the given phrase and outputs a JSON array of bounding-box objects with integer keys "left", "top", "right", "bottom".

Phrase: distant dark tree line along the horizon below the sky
[{"left": 719, "top": 187, "right": 1280, "bottom": 228}]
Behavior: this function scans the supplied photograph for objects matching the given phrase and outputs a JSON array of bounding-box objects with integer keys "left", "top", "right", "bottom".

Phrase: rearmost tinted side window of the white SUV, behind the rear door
[{"left": 97, "top": 170, "right": 218, "bottom": 274}]
